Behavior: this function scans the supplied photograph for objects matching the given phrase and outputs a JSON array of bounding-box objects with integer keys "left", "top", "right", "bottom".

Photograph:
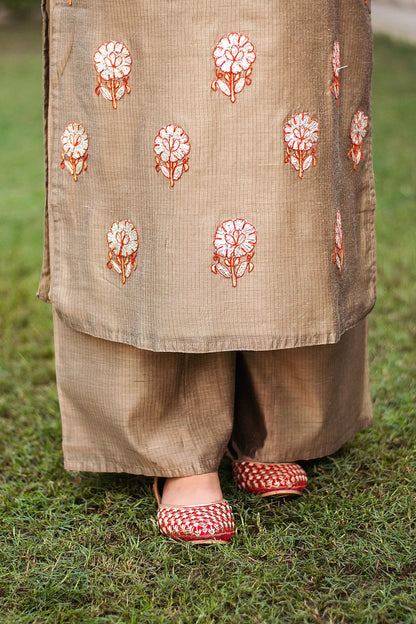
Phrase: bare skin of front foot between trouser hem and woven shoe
[{"left": 162, "top": 472, "right": 222, "bottom": 506}]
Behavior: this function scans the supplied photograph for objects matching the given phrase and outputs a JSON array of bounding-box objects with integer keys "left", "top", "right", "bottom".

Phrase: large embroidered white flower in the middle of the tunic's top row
[{"left": 211, "top": 33, "right": 256, "bottom": 103}]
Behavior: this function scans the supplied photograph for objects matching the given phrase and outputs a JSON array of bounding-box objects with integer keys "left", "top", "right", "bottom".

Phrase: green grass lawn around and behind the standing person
[{"left": 0, "top": 27, "right": 416, "bottom": 624}]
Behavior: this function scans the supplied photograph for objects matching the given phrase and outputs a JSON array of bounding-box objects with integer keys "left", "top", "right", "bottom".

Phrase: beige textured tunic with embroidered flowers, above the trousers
[{"left": 39, "top": 0, "right": 375, "bottom": 352}]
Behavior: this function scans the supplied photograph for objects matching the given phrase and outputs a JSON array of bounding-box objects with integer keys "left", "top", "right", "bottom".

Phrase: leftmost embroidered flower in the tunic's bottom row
[{"left": 107, "top": 219, "right": 139, "bottom": 284}]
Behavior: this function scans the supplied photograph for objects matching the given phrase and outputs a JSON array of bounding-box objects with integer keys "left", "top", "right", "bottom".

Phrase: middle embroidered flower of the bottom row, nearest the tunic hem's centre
[{"left": 211, "top": 219, "right": 257, "bottom": 288}]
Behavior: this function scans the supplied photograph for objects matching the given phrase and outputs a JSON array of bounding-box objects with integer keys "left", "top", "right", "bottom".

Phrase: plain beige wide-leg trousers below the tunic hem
[{"left": 54, "top": 310, "right": 372, "bottom": 476}]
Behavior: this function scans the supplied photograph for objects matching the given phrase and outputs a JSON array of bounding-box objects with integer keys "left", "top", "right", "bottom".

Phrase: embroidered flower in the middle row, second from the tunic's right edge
[{"left": 284, "top": 113, "right": 319, "bottom": 178}]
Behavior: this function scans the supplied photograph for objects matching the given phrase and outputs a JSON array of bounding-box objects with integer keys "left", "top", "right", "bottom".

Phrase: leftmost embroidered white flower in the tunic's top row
[{"left": 94, "top": 41, "right": 132, "bottom": 110}]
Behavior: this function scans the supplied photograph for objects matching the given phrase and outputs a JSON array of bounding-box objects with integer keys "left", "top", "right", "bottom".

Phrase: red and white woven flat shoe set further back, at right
[{"left": 233, "top": 461, "right": 308, "bottom": 496}]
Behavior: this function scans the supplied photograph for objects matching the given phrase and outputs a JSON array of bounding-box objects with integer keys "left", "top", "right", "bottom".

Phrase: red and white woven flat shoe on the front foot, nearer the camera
[{"left": 153, "top": 477, "right": 235, "bottom": 544}]
